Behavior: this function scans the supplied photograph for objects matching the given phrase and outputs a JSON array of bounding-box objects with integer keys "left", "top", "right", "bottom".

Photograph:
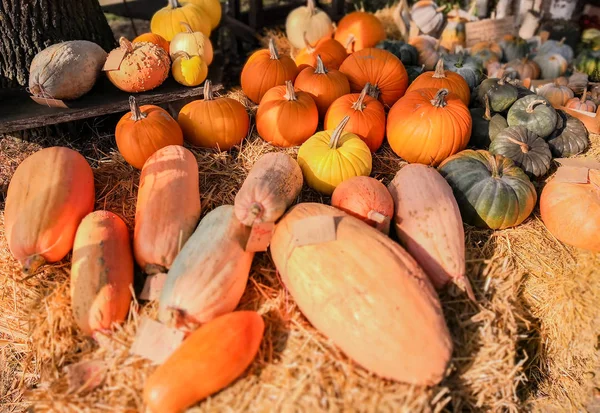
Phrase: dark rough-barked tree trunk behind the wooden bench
[{"left": 0, "top": 0, "right": 116, "bottom": 89}]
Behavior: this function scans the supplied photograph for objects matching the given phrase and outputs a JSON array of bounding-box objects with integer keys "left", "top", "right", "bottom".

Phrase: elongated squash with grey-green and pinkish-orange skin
[{"left": 158, "top": 205, "right": 254, "bottom": 328}]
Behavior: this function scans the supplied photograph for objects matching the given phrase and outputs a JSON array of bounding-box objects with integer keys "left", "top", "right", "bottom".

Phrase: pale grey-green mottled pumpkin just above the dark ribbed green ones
[{"left": 506, "top": 95, "right": 556, "bottom": 138}]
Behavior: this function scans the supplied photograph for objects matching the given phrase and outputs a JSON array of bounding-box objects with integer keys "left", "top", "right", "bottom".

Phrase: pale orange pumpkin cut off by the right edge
[{"left": 540, "top": 169, "right": 600, "bottom": 252}]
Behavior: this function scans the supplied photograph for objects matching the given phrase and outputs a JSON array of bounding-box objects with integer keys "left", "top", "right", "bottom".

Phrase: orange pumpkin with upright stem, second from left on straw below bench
[{"left": 177, "top": 80, "right": 250, "bottom": 151}]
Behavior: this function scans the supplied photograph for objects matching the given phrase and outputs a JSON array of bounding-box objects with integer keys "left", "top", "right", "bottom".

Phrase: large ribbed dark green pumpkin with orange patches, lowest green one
[{"left": 438, "top": 149, "right": 537, "bottom": 229}]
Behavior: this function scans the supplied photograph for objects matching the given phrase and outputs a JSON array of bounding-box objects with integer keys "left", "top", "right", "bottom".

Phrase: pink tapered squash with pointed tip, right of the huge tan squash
[{"left": 388, "top": 164, "right": 474, "bottom": 300}]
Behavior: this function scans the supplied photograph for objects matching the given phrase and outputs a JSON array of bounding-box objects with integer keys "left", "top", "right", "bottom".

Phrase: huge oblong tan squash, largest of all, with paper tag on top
[{"left": 271, "top": 203, "right": 452, "bottom": 385}]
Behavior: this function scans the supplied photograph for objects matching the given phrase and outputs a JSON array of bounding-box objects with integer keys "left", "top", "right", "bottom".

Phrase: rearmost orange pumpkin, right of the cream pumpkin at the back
[{"left": 334, "top": 11, "right": 386, "bottom": 53}]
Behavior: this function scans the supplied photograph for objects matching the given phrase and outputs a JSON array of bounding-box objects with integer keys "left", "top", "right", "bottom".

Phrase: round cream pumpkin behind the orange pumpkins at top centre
[{"left": 285, "top": 0, "right": 333, "bottom": 49}]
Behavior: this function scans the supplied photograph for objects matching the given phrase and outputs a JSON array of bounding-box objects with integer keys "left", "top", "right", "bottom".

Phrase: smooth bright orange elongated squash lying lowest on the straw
[{"left": 144, "top": 311, "right": 265, "bottom": 413}]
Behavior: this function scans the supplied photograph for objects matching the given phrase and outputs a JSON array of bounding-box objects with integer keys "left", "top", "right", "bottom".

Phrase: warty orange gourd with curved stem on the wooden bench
[{"left": 106, "top": 37, "right": 171, "bottom": 93}]
